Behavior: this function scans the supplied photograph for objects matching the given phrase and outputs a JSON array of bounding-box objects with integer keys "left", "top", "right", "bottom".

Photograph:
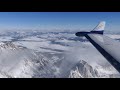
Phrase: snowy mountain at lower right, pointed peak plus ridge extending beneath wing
[{"left": 69, "top": 60, "right": 120, "bottom": 78}]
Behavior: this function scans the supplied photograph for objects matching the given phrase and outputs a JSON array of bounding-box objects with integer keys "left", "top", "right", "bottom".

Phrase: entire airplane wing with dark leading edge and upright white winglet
[{"left": 76, "top": 22, "right": 120, "bottom": 73}]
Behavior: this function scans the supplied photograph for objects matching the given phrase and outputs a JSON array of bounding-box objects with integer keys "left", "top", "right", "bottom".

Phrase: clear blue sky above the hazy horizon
[{"left": 0, "top": 12, "right": 120, "bottom": 31}]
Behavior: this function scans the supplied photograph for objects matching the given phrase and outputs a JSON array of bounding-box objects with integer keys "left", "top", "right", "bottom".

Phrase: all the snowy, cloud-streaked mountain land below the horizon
[{"left": 0, "top": 31, "right": 120, "bottom": 78}]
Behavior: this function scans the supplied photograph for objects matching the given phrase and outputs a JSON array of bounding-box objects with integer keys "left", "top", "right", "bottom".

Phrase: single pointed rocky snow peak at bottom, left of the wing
[{"left": 69, "top": 60, "right": 98, "bottom": 78}]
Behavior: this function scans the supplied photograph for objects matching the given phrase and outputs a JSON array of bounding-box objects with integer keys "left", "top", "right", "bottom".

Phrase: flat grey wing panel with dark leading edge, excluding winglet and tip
[{"left": 85, "top": 34, "right": 120, "bottom": 72}]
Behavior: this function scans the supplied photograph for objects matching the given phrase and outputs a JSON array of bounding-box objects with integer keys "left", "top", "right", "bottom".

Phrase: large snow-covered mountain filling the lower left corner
[{"left": 0, "top": 43, "right": 51, "bottom": 77}]
